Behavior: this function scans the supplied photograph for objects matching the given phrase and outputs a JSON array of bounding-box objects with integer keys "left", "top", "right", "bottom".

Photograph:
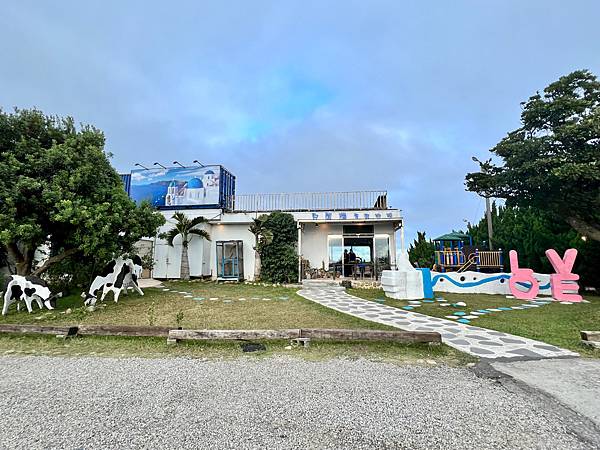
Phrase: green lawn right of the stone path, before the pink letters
[{"left": 348, "top": 289, "right": 600, "bottom": 358}]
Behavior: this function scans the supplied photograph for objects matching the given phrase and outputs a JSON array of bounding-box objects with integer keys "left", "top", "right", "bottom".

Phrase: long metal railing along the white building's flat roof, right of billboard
[{"left": 231, "top": 191, "right": 388, "bottom": 212}]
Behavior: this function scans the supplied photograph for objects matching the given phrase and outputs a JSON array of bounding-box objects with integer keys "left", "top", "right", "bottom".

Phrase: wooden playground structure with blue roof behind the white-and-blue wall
[{"left": 433, "top": 231, "right": 504, "bottom": 272}]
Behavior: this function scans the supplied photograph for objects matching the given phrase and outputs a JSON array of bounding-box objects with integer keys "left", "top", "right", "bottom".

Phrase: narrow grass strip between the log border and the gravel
[{"left": 0, "top": 334, "right": 476, "bottom": 366}]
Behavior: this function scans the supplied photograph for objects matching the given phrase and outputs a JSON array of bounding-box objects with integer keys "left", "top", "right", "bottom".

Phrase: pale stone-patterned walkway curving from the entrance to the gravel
[{"left": 298, "top": 286, "right": 579, "bottom": 360}]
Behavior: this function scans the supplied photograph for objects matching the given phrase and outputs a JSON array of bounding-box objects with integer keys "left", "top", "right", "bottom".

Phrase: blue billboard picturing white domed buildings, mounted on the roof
[{"left": 129, "top": 166, "right": 224, "bottom": 209}]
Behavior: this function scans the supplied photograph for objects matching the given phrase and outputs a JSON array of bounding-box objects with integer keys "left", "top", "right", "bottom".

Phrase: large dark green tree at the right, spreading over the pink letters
[{"left": 466, "top": 70, "right": 600, "bottom": 241}]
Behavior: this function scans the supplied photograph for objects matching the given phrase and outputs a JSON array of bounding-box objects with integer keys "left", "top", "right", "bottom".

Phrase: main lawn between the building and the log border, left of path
[{"left": 0, "top": 281, "right": 394, "bottom": 330}]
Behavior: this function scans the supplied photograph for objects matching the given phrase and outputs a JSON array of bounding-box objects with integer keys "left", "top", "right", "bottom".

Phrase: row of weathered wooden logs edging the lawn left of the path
[{"left": 0, "top": 324, "right": 440, "bottom": 343}]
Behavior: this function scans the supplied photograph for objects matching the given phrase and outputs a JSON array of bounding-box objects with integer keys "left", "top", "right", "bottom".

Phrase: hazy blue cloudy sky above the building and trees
[{"left": 0, "top": 0, "right": 600, "bottom": 244}]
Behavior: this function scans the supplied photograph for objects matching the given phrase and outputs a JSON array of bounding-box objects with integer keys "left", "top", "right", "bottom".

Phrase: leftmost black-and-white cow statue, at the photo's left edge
[{"left": 2, "top": 275, "right": 62, "bottom": 316}]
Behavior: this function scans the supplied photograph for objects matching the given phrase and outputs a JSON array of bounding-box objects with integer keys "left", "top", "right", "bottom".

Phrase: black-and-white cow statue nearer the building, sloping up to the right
[{"left": 81, "top": 255, "right": 144, "bottom": 306}]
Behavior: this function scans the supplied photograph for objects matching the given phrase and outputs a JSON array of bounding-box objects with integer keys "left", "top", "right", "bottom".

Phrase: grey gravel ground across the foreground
[{"left": 0, "top": 357, "right": 585, "bottom": 449}]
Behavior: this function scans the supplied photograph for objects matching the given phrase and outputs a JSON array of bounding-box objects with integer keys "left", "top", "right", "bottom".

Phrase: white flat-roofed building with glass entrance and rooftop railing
[{"left": 126, "top": 166, "right": 403, "bottom": 280}]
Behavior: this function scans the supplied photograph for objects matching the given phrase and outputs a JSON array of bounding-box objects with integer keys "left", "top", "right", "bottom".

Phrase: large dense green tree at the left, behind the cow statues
[{"left": 0, "top": 110, "right": 164, "bottom": 275}]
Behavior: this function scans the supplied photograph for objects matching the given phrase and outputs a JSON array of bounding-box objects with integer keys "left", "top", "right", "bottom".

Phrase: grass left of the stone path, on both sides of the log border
[{"left": 0, "top": 281, "right": 474, "bottom": 365}]
